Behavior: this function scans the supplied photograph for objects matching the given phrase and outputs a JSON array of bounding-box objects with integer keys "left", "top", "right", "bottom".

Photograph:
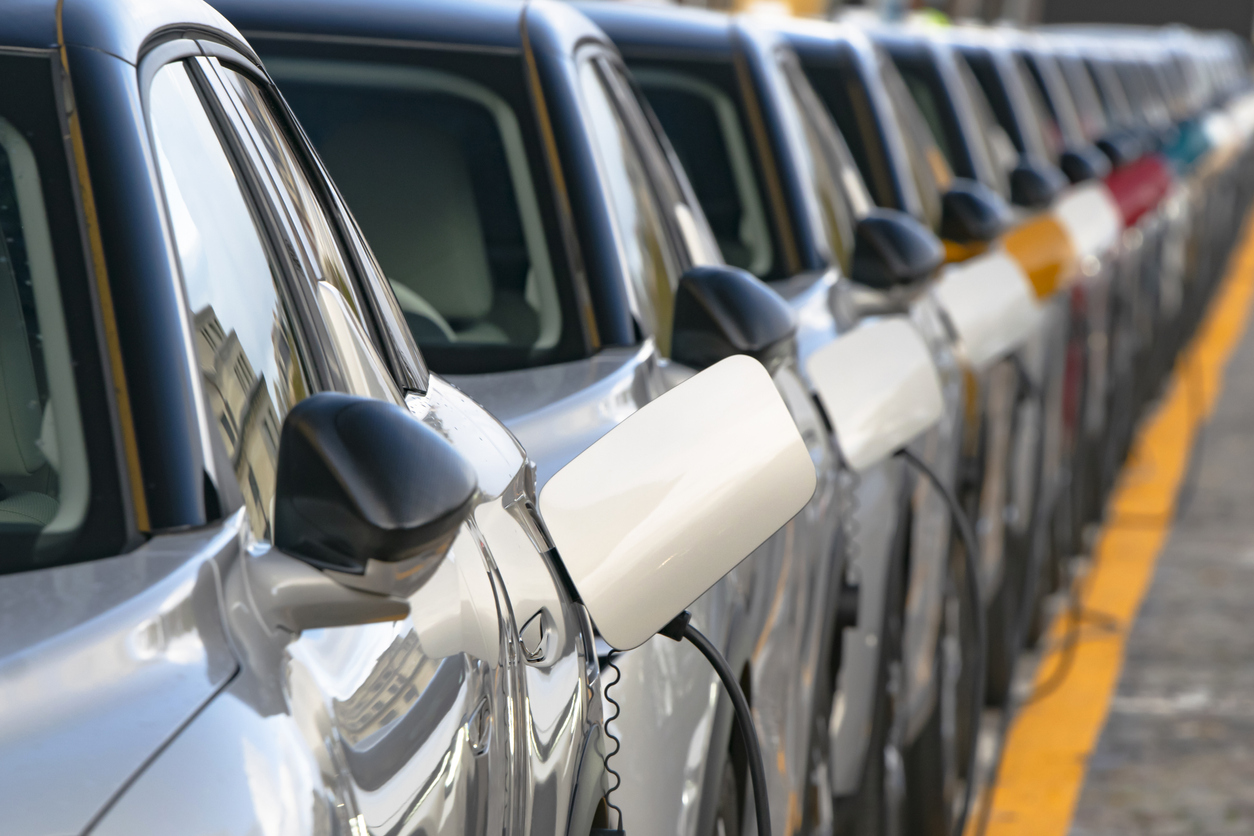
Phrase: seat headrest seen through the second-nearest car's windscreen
[{"left": 319, "top": 118, "right": 493, "bottom": 320}]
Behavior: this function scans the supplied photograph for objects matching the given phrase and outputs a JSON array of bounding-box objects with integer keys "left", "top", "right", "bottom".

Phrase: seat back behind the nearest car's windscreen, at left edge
[{"left": 0, "top": 237, "right": 44, "bottom": 481}]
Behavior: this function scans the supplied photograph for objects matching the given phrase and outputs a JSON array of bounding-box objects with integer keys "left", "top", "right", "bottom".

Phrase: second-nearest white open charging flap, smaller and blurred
[{"left": 805, "top": 316, "right": 944, "bottom": 471}]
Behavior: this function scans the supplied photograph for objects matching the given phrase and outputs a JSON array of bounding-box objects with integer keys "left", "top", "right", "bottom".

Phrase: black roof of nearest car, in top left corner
[{"left": 0, "top": 0, "right": 243, "bottom": 64}]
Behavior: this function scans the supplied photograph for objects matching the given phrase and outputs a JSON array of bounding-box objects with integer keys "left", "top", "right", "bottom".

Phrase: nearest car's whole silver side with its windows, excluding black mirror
[{"left": 91, "top": 41, "right": 587, "bottom": 833}]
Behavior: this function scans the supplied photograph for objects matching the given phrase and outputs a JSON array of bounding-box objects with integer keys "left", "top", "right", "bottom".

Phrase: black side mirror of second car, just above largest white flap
[{"left": 671, "top": 266, "right": 796, "bottom": 370}]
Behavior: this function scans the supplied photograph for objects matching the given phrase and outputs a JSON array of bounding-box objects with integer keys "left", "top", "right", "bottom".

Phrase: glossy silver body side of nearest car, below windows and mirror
[{"left": 87, "top": 377, "right": 601, "bottom": 833}]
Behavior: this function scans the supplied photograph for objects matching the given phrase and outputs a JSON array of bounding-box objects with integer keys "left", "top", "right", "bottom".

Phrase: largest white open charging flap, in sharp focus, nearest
[{"left": 539, "top": 356, "right": 816, "bottom": 651}]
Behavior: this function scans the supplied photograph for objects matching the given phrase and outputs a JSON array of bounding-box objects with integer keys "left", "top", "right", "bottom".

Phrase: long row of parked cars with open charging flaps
[{"left": 0, "top": 0, "right": 1254, "bottom": 836}]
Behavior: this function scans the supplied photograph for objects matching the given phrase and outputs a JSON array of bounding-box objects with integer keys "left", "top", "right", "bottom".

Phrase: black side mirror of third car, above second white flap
[{"left": 849, "top": 209, "right": 944, "bottom": 290}]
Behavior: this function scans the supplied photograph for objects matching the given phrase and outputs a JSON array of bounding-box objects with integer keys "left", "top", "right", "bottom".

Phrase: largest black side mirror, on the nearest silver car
[{"left": 273, "top": 392, "right": 477, "bottom": 574}]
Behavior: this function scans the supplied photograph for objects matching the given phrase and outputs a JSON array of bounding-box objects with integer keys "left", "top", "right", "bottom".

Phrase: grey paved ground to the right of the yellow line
[{"left": 1071, "top": 312, "right": 1254, "bottom": 836}]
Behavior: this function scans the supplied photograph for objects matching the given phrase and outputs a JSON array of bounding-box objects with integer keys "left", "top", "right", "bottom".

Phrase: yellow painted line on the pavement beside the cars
[{"left": 987, "top": 214, "right": 1254, "bottom": 836}]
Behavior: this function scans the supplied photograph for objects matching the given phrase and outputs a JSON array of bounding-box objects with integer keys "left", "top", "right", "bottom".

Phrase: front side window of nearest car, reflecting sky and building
[{"left": 149, "top": 64, "right": 312, "bottom": 539}]
